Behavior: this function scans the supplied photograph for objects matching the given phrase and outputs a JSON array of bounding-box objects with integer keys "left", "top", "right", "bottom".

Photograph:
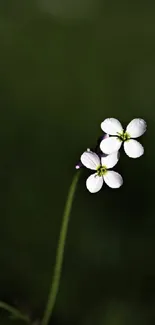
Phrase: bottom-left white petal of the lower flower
[{"left": 86, "top": 173, "right": 103, "bottom": 193}]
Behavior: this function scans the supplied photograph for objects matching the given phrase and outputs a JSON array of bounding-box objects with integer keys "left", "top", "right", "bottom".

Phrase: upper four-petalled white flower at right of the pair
[{"left": 100, "top": 118, "right": 146, "bottom": 158}]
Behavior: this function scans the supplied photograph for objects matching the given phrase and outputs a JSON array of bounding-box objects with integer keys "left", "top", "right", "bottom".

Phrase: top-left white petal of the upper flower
[{"left": 101, "top": 118, "right": 123, "bottom": 135}]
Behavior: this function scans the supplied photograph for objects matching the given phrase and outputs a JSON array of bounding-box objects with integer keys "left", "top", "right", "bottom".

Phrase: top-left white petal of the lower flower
[{"left": 81, "top": 151, "right": 101, "bottom": 170}]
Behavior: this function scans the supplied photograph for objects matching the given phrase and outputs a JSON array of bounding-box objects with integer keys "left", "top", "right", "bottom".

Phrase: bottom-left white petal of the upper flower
[{"left": 100, "top": 137, "right": 122, "bottom": 155}]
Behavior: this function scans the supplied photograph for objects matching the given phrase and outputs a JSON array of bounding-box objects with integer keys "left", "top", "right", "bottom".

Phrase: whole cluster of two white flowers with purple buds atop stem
[{"left": 76, "top": 118, "right": 147, "bottom": 193}]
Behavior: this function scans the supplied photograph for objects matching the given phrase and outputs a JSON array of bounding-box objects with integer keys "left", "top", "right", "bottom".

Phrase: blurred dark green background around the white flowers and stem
[{"left": 0, "top": 0, "right": 155, "bottom": 325}]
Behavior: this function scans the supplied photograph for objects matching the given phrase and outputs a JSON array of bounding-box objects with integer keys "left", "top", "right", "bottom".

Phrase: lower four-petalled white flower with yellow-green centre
[{"left": 81, "top": 151, "right": 123, "bottom": 193}]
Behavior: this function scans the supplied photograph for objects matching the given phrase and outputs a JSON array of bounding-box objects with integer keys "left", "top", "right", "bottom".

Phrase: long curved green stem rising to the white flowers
[{"left": 41, "top": 172, "right": 80, "bottom": 325}]
